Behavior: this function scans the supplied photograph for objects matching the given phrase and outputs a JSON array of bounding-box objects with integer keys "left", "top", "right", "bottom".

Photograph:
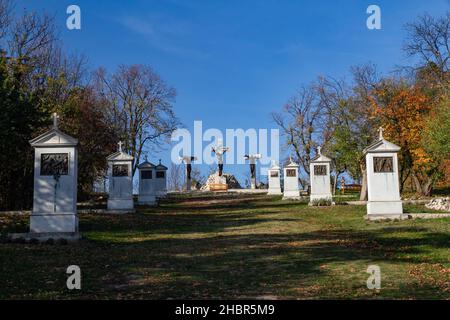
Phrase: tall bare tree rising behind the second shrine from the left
[{"left": 95, "top": 65, "right": 179, "bottom": 175}]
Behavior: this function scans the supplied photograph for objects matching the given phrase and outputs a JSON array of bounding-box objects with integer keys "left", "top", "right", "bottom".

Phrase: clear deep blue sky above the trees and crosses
[{"left": 17, "top": 0, "right": 450, "bottom": 182}]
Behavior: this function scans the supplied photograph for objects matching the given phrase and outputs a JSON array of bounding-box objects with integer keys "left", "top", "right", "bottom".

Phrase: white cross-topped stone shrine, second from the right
[{"left": 309, "top": 146, "right": 332, "bottom": 204}]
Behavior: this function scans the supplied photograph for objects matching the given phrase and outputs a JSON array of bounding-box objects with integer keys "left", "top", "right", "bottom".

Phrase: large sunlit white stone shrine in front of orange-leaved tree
[{"left": 363, "top": 128, "right": 403, "bottom": 220}]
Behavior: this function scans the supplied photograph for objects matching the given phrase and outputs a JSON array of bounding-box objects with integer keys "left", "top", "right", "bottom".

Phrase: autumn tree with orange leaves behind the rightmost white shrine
[{"left": 371, "top": 79, "right": 440, "bottom": 195}]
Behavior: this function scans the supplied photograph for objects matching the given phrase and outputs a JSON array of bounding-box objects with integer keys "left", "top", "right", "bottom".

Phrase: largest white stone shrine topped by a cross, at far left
[{"left": 29, "top": 113, "right": 79, "bottom": 238}]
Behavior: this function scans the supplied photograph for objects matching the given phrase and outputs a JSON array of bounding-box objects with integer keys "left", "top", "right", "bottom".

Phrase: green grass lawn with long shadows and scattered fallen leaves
[{"left": 0, "top": 195, "right": 450, "bottom": 299}]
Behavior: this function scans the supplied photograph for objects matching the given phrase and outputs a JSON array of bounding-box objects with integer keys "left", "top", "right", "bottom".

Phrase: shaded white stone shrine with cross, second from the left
[{"left": 106, "top": 141, "right": 134, "bottom": 213}]
